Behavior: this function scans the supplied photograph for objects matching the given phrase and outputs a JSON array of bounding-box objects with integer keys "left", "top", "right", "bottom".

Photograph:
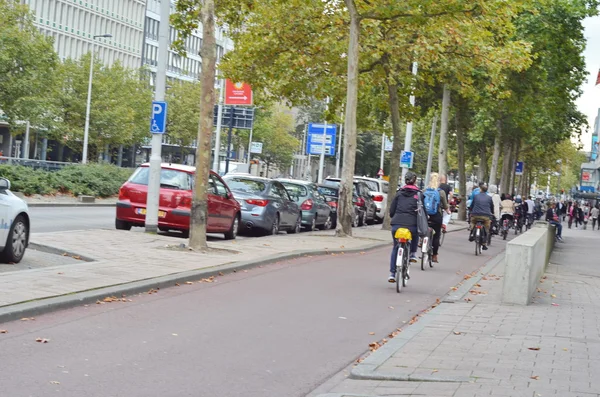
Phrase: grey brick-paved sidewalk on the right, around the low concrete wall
[{"left": 320, "top": 229, "right": 600, "bottom": 397}]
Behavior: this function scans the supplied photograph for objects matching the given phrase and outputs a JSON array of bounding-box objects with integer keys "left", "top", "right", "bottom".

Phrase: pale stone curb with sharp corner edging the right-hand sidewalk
[{"left": 346, "top": 252, "right": 505, "bottom": 382}]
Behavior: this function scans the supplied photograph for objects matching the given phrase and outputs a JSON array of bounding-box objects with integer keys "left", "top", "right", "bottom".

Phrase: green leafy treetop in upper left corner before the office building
[{"left": 0, "top": 0, "right": 58, "bottom": 121}]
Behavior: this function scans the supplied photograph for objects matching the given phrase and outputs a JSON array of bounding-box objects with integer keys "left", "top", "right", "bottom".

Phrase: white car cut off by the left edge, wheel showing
[{"left": 0, "top": 178, "right": 30, "bottom": 263}]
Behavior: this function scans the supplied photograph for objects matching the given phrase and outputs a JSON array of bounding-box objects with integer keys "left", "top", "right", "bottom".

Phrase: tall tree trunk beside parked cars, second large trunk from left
[{"left": 336, "top": 0, "right": 360, "bottom": 237}]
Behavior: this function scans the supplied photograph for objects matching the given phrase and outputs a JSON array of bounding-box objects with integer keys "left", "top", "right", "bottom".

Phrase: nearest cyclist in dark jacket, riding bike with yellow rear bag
[{"left": 388, "top": 171, "right": 424, "bottom": 283}]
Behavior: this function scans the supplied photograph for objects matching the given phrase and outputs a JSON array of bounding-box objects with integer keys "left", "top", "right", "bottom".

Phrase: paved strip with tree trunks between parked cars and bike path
[{"left": 0, "top": 222, "right": 464, "bottom": 322}]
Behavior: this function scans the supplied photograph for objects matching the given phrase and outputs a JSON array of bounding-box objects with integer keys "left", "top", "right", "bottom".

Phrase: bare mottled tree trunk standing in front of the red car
[{"left": 190, "top": 0, "right": 216, "bottom": 250}]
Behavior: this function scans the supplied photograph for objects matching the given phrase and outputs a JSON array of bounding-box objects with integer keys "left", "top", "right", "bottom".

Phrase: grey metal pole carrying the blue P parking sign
[{"left": 145, "top": 0, "right": 171, "bottom": 233}]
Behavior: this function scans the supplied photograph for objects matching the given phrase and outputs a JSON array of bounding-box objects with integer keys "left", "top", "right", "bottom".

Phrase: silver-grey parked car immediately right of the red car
[{"left": 224, "top": 175, "right": 302, "bottom": 234}]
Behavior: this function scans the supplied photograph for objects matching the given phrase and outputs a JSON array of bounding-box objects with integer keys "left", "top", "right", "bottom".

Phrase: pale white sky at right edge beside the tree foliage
[{"left": 576, "top": 16, "right": 600, "bottom": 151}]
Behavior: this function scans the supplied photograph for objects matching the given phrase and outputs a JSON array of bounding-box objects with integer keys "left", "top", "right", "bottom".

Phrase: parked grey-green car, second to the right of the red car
[{"left": 277, "top": 179, "right": 331, "bottom": 231}]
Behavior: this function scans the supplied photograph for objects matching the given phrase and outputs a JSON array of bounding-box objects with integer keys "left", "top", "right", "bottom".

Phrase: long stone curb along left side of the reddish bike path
[{"left": 0, "top": 242, "right": 391, "bottom": 324}]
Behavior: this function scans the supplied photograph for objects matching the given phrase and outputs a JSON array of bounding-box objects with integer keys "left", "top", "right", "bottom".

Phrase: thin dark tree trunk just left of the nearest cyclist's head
[{"left": 382, "top": 68, "right": 402, "bottom": 230}]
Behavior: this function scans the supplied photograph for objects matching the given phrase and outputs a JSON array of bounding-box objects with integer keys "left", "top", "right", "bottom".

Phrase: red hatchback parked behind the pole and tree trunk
[{"left": 115, "top": 164, "right": 241, "bottom": 240}]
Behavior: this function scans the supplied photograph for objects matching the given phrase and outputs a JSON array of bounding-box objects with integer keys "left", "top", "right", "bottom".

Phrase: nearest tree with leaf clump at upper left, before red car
[{"left": 171, "top": 0, "right": 217, "bottom": 250}]
